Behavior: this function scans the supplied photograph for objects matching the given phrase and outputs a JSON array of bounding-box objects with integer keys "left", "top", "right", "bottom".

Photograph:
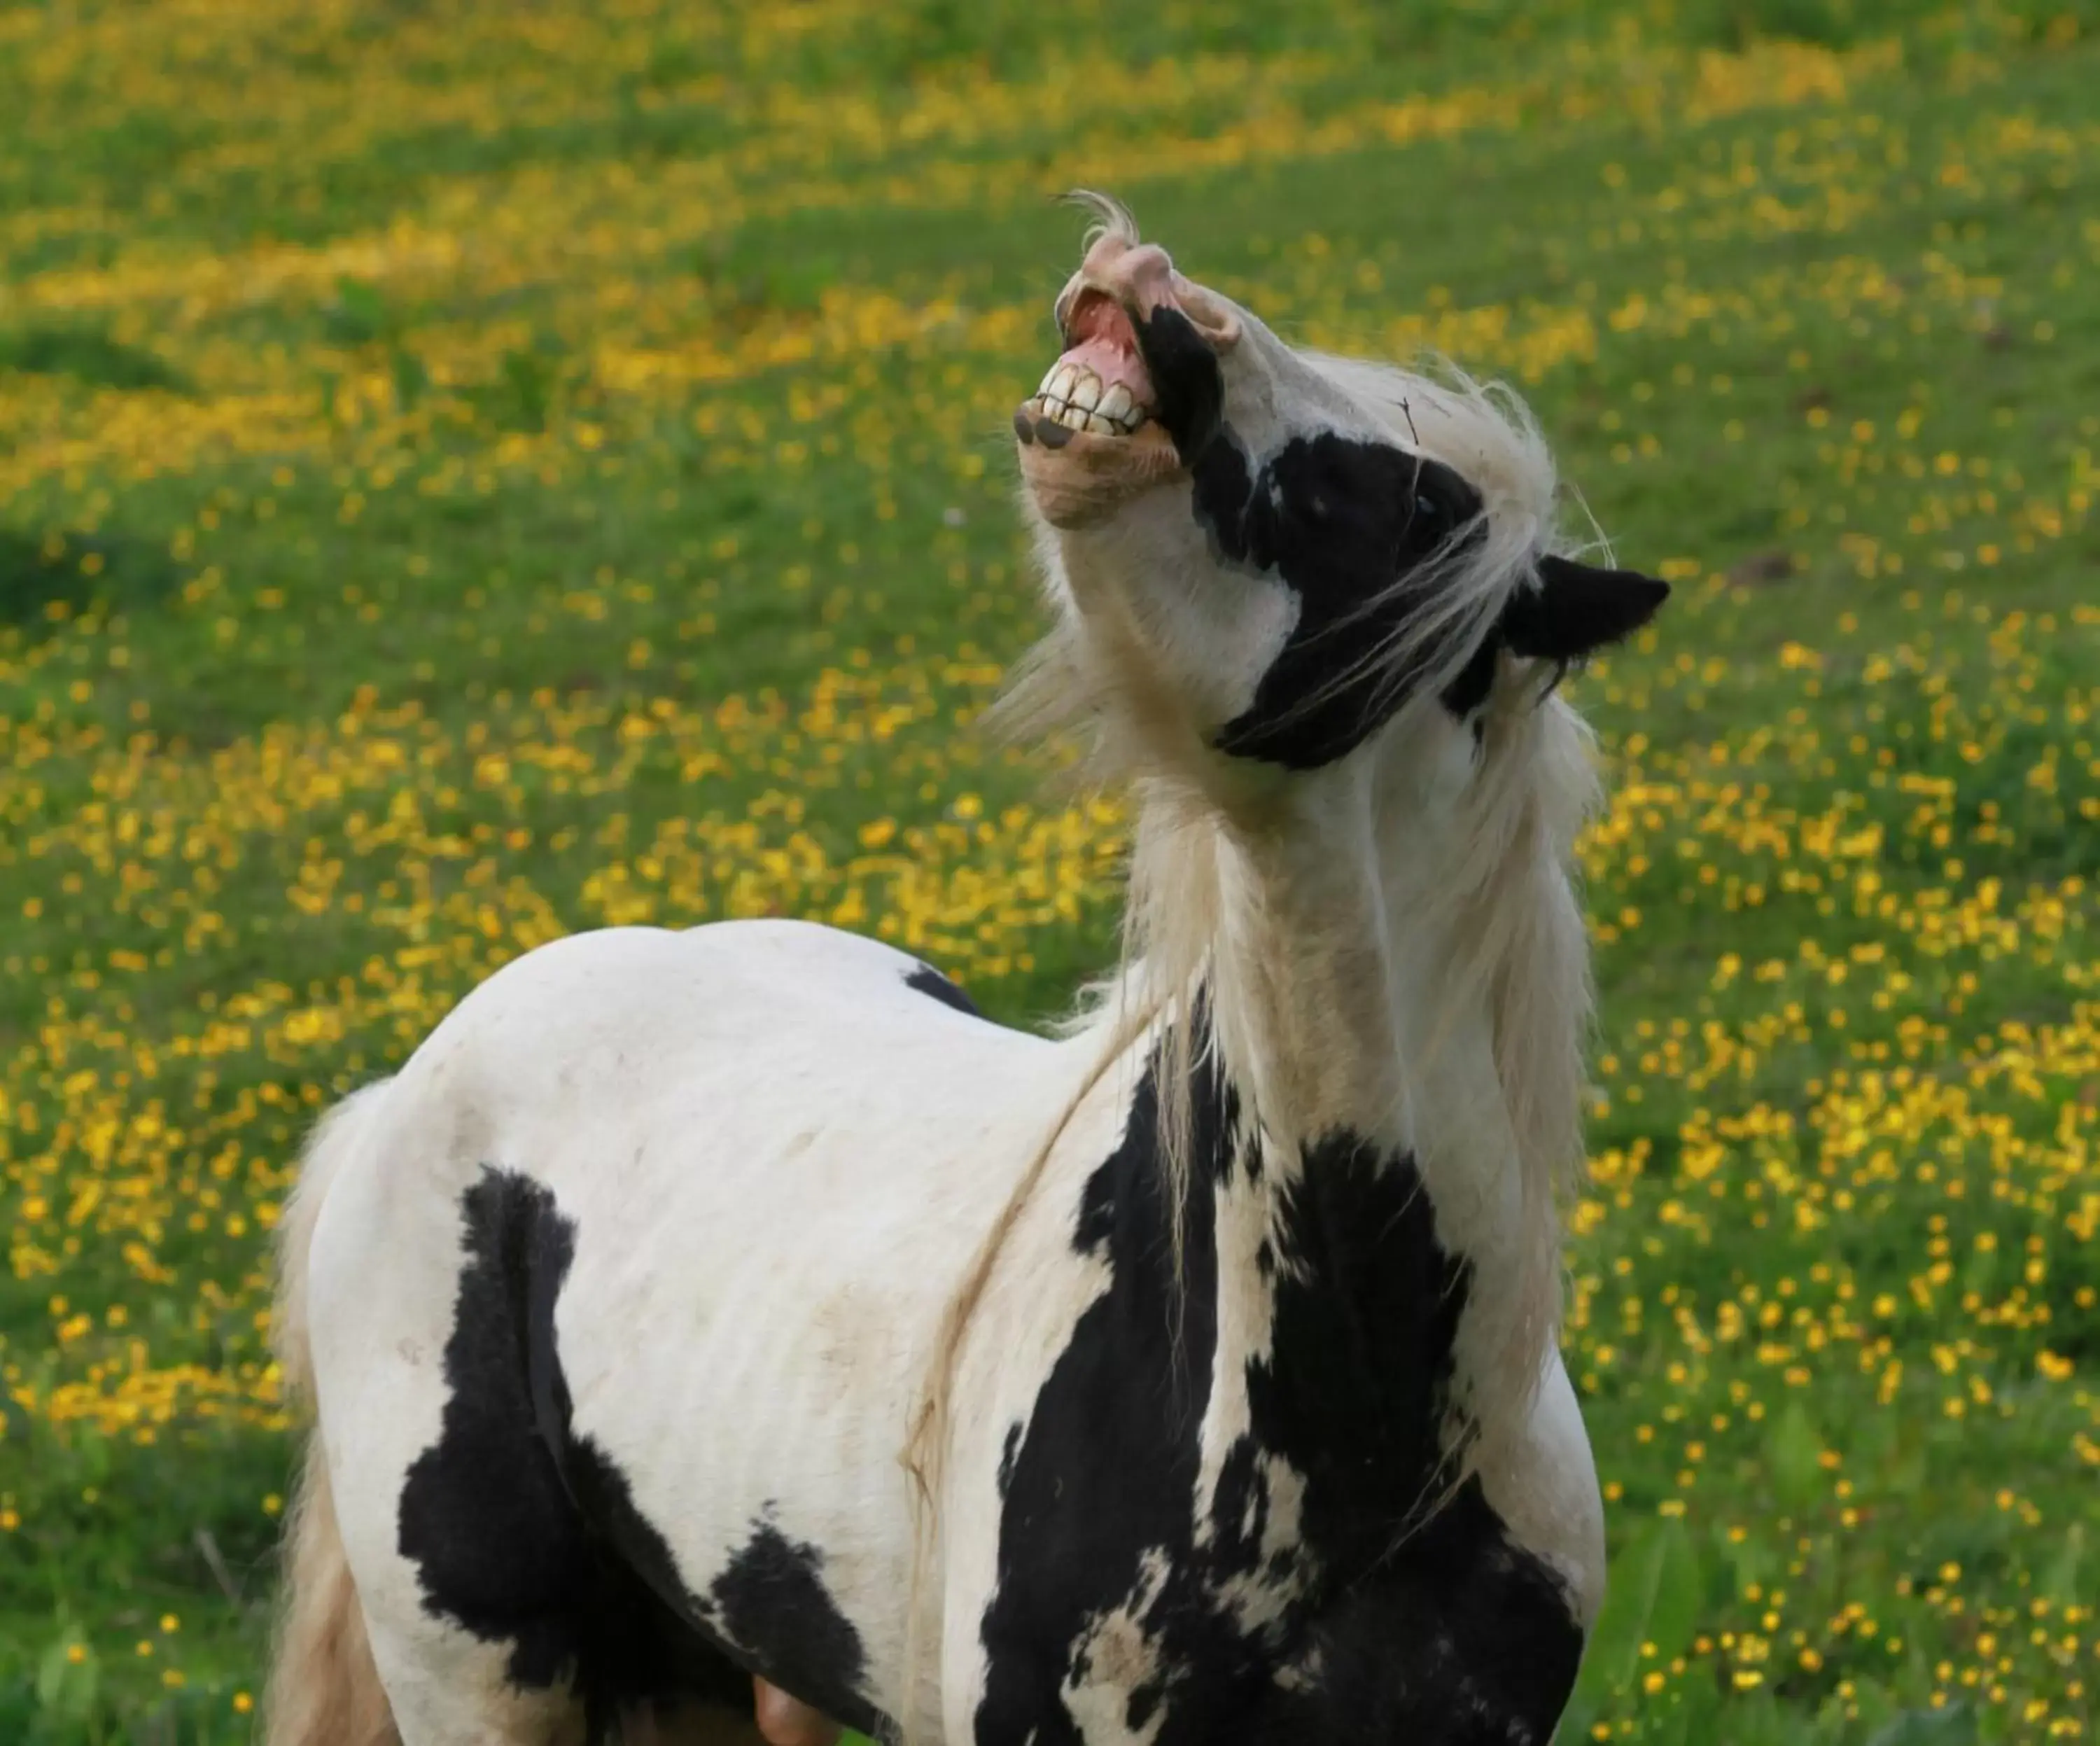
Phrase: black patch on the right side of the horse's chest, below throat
[{"left": 1245, "top": 1133, "right": 1581, "bottom": 1746}]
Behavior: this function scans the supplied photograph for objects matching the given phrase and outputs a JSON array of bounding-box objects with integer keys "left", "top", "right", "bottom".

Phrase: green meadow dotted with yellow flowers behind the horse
[{"left": 0, "top": 0, "right": 2100, "bottom": 1746}]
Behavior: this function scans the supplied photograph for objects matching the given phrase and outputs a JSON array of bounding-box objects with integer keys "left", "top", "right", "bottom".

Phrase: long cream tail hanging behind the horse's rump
[{"left": 262, "top": 1084, "right": 401, "bottom": 1746}]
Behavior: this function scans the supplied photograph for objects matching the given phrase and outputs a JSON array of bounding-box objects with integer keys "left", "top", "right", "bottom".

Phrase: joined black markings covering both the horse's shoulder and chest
[{"left": 976, "top": 1017, "right": 1581, "bottom": 1746}]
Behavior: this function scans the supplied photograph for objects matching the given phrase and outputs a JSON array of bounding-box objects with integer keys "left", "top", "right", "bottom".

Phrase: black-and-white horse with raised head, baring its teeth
[{"left": 267, "top": 197, "right": 1667, "bottom": 1746}]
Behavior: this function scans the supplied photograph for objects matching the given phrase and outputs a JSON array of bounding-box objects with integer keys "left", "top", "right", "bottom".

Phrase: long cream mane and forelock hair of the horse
[{"left": 903, "top": 321, "right": 1596, "bottom": 1738}]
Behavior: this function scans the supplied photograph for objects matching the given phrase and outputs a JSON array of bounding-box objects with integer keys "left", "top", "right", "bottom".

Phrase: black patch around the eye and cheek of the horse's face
[{"left": 1193, "top": 424, "right": 1491, "bottom": 769}]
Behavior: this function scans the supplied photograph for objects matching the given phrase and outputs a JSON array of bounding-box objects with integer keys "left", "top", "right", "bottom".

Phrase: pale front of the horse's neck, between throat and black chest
[{"left": 1140, "top": 773, "right": 1558, "bottom": 1423}]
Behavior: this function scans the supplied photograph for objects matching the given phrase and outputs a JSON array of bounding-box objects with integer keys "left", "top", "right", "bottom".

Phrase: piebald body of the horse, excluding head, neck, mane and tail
[{"left": 309, "top": 923, "right": 1596, "bottom": 1742}]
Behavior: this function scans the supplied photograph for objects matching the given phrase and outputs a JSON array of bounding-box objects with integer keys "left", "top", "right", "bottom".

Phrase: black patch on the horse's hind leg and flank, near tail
[{"left": 397, "top": 1168, "right": 882, "bottom": 1742}]
